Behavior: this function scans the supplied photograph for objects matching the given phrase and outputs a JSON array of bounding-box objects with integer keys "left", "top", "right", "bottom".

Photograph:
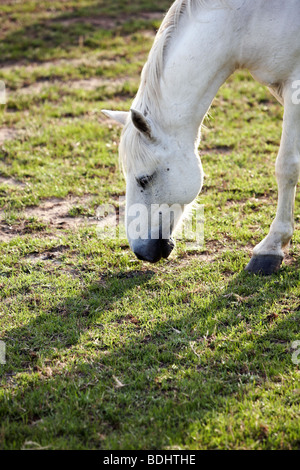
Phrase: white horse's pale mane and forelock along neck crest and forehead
[{"left": 119, "top": 0, "right": 229, "bottom": 173}]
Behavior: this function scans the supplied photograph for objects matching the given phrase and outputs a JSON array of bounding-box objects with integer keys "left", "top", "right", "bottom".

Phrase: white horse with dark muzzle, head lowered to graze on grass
[{"left": 104, "top": 0, "right": 300, "bottom": 274}]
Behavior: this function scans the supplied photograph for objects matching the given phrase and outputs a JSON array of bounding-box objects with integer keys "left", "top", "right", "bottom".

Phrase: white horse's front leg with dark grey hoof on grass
[{"left": 246, "top": 83, "right": 300, "bottom": 275}]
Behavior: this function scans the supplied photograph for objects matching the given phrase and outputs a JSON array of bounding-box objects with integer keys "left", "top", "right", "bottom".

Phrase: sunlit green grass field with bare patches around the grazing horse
[{"left": 0, "top": 0, "right": 300, "bottom": 450}]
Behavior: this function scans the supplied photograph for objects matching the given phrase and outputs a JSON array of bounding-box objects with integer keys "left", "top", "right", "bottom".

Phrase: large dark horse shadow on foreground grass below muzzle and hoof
[{"left": 3, "top": 258, "right": 299, "bottom": 449}]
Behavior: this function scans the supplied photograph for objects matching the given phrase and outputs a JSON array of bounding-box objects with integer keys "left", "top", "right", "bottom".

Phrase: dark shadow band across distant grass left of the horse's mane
[{"left": 0, "top": 0, "right": 172, "bottom": 64}]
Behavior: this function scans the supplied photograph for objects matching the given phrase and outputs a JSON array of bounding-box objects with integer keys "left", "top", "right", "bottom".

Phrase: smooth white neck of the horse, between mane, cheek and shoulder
[{"left": 145, "top": 9, "right": 237, "bottom": 143}]
